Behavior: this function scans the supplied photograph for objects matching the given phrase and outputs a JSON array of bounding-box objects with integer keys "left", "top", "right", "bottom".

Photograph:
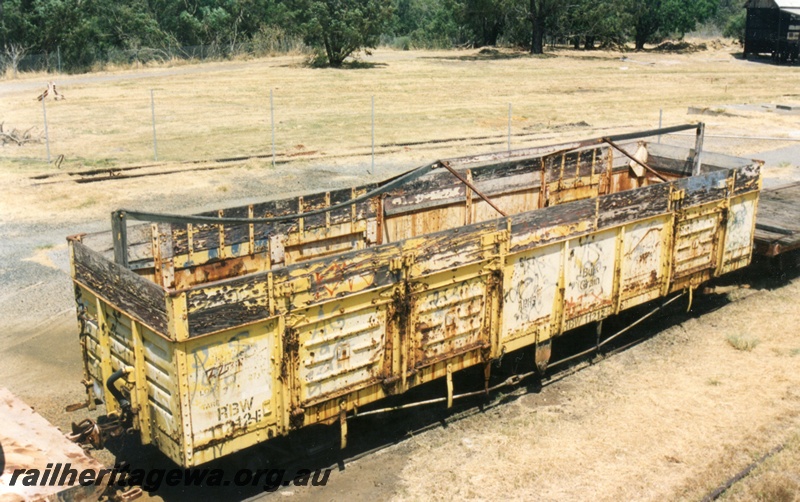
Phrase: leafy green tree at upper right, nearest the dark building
[{"left": 628, "top": 0, "right": 719, "bottom": 50}]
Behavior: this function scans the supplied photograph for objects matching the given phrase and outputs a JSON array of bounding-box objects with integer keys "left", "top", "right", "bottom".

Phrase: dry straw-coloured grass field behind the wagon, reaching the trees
[{"left": 0, "top": 39, "right": 800, "bottom": 227}]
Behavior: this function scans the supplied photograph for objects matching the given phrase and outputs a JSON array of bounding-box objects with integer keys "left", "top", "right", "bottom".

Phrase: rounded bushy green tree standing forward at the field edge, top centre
[{"left": 294, "top": 0, "right": 393, "bottom": 68}]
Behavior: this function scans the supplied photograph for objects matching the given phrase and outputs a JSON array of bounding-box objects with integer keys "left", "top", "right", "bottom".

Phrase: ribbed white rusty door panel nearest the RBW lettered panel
[{"left": 296, "top": 295, "right": 387, "bottom": 406}]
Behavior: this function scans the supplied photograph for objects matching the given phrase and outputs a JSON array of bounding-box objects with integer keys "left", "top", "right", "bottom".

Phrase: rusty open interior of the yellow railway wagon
[{"left": 78, "top": 137, "right": 744, "bottom": 290}]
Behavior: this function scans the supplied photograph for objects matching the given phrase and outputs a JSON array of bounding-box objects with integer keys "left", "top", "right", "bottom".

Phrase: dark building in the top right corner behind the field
[{"left": 744, "top": 0, "right": 800, "bottom": 62}]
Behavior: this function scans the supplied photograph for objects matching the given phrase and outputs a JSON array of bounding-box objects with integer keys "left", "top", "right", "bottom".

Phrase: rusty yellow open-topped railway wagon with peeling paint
[{"left": 69, "top": 125, "right": 760, "bottom": 466}]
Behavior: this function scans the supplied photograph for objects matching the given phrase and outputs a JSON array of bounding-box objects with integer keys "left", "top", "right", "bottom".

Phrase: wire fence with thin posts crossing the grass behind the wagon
[{"left": 0, "top": 85, "right": 800, "bottom": 180}]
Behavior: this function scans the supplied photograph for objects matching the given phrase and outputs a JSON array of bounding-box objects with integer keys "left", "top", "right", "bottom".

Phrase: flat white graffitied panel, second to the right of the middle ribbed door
[{"left": 564, "top": 230, "right": 617, "bottom": 329}]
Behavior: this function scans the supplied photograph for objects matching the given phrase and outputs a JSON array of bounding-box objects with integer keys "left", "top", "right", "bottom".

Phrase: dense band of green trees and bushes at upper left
[{"left": 0, "top": 0, "right": 300, "bottom": 71}]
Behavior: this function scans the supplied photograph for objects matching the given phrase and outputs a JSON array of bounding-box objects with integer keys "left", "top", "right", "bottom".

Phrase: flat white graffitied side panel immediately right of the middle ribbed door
[{"left": 500, "top": 243, "right": 563, "bottom": 342}]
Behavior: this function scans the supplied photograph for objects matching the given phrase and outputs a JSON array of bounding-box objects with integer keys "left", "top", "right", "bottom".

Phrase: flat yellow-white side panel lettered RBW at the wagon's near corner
[{"left": 186, "top": 321, "right": 277, "bottom": 449}]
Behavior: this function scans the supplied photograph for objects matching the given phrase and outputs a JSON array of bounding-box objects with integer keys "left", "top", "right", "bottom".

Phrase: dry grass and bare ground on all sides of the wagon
[{"left": 0, "top": 43, "right": 800, "bottom": 501}]
